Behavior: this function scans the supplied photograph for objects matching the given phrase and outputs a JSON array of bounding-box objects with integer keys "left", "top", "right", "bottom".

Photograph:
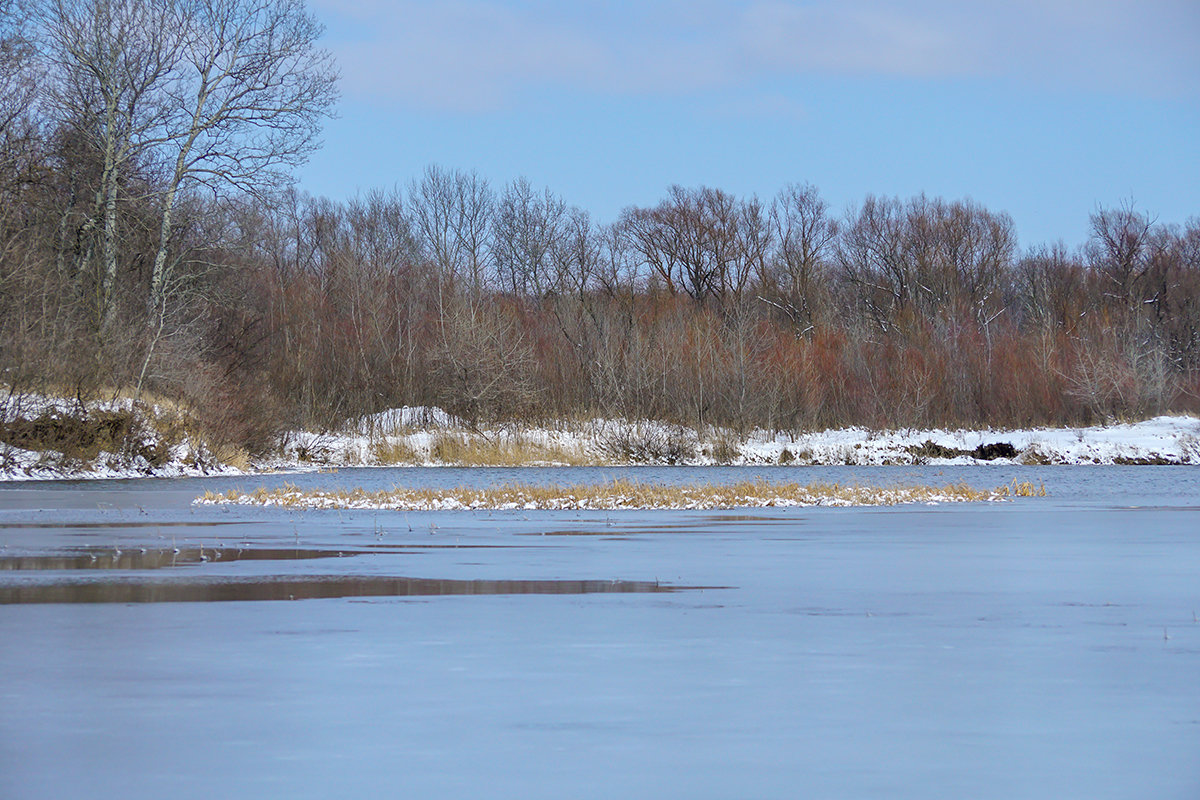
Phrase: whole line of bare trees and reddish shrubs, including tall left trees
[{"left": 0, "top": 0, "right": 1200, "bottom": 450}]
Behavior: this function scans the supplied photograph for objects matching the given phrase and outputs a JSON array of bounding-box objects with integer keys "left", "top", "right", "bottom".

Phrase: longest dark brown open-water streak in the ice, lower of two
[{"left": 0, "top": 576, "right": 700, "bottom": 604}]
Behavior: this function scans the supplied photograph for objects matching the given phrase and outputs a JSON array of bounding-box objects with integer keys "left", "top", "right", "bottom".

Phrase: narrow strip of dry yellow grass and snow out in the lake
[{"left": 198, "top": 480, "right": 1045, "bottom": 511}]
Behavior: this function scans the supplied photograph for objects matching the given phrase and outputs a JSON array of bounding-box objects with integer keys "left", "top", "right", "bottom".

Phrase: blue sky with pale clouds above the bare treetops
[{"left": 300, "top": 0, "right": 1200, "bottom": 245}]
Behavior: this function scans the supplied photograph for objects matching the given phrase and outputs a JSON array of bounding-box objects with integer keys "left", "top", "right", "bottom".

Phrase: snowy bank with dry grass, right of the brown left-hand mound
[{"left": 270, "top": 409, "right": 1200, "bottom": 469}]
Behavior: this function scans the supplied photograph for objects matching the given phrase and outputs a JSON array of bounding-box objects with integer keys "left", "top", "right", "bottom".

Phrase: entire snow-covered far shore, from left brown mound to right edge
[{"left": 0, "top": 391, "right": 1200, "bottom": 480}]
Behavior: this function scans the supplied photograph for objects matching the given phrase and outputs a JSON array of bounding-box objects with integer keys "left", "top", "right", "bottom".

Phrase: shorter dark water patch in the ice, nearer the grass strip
[{"left": 0, "top": 547, "right": 359, "bottom": 572}]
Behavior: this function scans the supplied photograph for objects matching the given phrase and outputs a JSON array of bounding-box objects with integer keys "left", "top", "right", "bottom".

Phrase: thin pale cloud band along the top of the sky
[{"left": 317, "top": 0, "right": 1200, "bottom": 112}]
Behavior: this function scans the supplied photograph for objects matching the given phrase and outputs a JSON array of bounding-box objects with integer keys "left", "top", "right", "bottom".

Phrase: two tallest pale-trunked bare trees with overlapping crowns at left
[{"left": 37, "top": 0, "right": 337, "bottom": 327}]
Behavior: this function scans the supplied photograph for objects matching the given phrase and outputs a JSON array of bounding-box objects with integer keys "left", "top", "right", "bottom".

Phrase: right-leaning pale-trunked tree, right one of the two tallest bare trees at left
[{"left": 150, "top": 0, "right": 337, "bottom": 316}]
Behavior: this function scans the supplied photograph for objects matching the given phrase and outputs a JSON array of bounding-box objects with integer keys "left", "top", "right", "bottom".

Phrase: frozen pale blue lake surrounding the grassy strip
[{"left": 0, "top": 467, "right": 1200, "bottom": 800}]
